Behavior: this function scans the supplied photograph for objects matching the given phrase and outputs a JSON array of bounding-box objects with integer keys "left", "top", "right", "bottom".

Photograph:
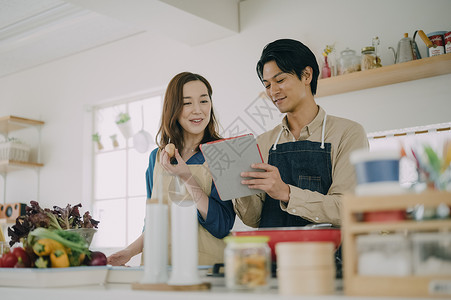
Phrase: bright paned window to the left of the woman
[{"left": 92, "top": 91, "right": 163, "bottom": 248}]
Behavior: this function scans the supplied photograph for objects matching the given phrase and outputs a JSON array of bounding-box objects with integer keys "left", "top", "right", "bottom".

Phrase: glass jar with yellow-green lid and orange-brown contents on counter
[{"left": 224, "top": 236, "right": 271, "bottom": 290}]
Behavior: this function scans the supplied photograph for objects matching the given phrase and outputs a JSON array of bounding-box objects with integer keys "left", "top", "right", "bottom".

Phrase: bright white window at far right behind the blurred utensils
[{"left": 368, "top": 123, "right": 451, "bottom": 187}]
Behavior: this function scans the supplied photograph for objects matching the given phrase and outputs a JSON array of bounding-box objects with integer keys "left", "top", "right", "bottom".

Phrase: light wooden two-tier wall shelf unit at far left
[{"left": 0, "top": 116, "right": 44, "bottom": 203}]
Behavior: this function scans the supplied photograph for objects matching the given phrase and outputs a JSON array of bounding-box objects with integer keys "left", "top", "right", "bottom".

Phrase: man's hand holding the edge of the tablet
[{"left": 241, "top": 163, "right": 290, "bottom": 202}]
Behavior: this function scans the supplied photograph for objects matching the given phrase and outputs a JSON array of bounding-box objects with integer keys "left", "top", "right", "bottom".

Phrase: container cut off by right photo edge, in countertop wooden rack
[{"left": 412, "top": 233, "right": 451, "bottom": 276}]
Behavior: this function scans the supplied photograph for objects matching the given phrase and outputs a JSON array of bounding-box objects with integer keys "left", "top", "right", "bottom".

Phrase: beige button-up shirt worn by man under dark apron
[{"left": 233, "top": 107, "right": 369, "bottom": 227}]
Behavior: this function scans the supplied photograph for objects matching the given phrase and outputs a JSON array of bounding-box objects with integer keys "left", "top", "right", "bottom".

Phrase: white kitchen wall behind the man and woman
[{"left": 0, "top": 0, "right": 451, "bottom": 209}]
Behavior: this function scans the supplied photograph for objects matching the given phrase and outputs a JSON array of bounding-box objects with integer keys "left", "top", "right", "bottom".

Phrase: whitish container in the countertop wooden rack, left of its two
[{"left": 356, "top": 234, "right": 412, "bottom": 276}]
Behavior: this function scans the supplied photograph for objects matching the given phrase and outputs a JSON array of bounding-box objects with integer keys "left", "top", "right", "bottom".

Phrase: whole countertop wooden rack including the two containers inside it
[{"left": 342, "top": 190, "right": 451, "bottom": 297}]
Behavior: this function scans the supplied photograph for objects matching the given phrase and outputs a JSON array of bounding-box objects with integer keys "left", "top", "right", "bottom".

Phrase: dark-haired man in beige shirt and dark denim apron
[{"left": 234, "top": 39, "right": 368, "bottom": 227}]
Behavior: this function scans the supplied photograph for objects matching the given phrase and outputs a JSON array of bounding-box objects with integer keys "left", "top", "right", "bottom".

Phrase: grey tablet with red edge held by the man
[{"left": 200, "top": 133, "right": 264, "bottom": 200}]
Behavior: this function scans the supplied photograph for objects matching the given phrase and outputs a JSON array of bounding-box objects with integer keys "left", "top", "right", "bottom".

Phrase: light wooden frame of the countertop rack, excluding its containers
[{"left": 342, "top": 191, "right": 451, "bottom": 297}]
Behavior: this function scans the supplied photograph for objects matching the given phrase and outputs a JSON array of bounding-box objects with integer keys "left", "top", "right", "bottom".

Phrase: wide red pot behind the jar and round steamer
[{"left": 231, "top": 224, "right": 341, "bottom": 261}]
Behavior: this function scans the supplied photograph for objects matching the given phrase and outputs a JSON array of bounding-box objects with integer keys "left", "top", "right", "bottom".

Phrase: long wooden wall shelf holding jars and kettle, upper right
[{"left": 316, "top": 53, "right": 451, "bottom": 98}]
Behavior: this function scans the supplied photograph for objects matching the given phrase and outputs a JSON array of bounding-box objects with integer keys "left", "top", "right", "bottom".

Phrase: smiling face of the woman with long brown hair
[{"left": 178, "top": 80, "right": 211, "bottom": 137}]
